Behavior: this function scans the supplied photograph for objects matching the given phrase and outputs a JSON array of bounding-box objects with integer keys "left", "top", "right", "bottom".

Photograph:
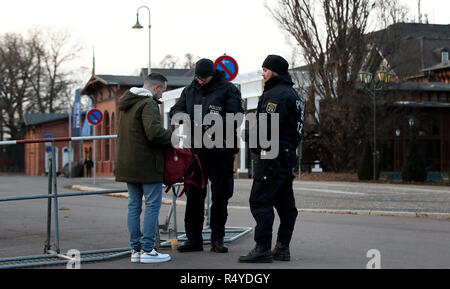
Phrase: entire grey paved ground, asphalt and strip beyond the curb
[{"left": 0, "top": 176, "right": 450, "bottom": 269}]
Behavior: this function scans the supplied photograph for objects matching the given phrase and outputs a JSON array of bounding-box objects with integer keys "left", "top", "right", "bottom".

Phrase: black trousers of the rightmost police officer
[{"left": 250, "top": 160, "right": 298, "bottom": 250}]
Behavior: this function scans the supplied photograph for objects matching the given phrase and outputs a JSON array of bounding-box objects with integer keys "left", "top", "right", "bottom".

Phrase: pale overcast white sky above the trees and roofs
[{"left": 0, "top": 0, "right": 450, "bottom": 80}]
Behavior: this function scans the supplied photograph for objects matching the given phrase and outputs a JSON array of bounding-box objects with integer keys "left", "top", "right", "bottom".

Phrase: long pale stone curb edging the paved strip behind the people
[{"left": 72, "top": 185, "right": 450, "bottom": 220}]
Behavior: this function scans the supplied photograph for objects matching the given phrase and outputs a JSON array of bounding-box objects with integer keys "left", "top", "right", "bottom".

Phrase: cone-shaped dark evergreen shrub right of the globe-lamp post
[{"left": 402, "top": 137, "right": 427, "bottom": 182}]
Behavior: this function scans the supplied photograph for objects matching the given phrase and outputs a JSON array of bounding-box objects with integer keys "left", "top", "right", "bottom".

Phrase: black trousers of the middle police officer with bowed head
[{"left": 184, "top": 150, "right": 234, "bottom": 243}]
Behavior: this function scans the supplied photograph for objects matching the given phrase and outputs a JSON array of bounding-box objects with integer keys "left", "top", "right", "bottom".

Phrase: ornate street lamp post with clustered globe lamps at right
[{"left": 359, "top": 68, "right": 391, "bottom": 180}]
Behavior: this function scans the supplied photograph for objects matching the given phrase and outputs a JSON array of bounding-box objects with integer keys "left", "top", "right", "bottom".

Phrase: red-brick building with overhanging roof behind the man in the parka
[{"left": 25, "top": 68, "right": 194, "bottom": 176}]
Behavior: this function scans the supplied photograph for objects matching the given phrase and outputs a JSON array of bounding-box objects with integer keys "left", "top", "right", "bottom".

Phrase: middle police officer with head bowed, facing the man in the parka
[{"left": 169, "top": 59, "right": 243, "bottom": 253}]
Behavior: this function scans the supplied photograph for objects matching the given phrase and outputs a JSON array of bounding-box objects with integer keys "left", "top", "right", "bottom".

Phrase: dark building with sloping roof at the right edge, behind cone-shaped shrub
[{"left": 367, "top": 23, "right": 450, "bottom": 172}]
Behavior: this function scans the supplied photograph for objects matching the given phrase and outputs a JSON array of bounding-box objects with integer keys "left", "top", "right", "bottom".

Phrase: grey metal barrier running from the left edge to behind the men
[{"left": 0, "top": 135, "right": 252, "bottom": 269}]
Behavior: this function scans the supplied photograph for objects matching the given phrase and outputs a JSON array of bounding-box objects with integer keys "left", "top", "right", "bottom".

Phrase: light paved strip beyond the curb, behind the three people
[{"left": 61, "top": 178, "right": 450, "bottom": 216}]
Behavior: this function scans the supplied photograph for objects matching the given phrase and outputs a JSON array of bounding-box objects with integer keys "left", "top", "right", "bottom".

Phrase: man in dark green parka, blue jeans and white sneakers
[{"left": 115, "top": 73, "right": 172, "bottom": 263}]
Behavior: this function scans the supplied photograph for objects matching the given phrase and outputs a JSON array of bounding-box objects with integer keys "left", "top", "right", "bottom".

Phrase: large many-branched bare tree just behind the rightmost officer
[{"left": 266, "top": 0, "right": 412, "bottom": 171}]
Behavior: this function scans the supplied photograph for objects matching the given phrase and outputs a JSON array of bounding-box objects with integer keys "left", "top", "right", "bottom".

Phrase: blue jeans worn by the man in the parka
[{"left": 127, "top": 183, "right": 162, "bottom": 251}]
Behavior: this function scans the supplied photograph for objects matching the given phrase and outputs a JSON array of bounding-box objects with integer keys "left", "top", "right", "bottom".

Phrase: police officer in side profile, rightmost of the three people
[{"left": 239, "top": 55, "right": 304, "bottom": 263}]
